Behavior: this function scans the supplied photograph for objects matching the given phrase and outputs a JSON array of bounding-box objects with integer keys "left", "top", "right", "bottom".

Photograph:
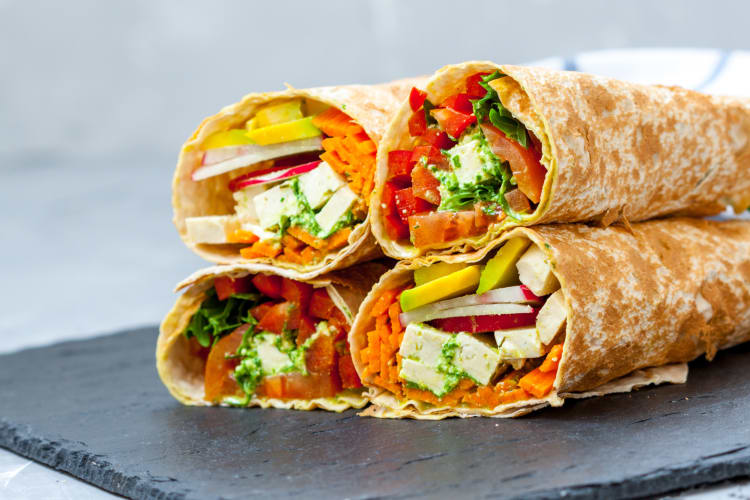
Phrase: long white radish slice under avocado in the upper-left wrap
[{"left": 192, "top": 137, "right": 323, "bottom": 181}]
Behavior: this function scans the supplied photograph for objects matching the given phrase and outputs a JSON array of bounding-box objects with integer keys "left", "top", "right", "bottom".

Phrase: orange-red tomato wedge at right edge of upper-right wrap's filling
[{"left": 481, "top": 123, "right": 547, "bottom": 203}]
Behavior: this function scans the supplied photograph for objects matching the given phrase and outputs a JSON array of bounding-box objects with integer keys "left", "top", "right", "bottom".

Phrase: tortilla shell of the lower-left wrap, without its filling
[{"left": 156, "top": 262, "right": 388, "bottom": 411}]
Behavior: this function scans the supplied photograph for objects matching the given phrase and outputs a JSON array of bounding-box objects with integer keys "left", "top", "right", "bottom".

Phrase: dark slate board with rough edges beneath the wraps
[{"left": 0, "top": 328, "right": 750, "bottom": 498}]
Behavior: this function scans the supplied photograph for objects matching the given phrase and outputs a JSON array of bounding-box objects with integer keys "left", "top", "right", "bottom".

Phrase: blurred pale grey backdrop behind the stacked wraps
[{"left": 0, "top": 0, "right": 750, "bottom": 350}]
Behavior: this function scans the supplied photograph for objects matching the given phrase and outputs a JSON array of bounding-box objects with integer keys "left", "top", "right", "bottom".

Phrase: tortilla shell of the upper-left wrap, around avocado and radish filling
[{"left": 172, "top": 78, "right": 426, "bottom": 279}]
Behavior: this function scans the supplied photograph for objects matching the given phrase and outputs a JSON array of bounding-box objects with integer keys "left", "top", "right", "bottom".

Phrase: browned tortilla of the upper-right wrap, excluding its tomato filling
[{"left": 370, "top": 62, "right": 750, "bottom": 259}]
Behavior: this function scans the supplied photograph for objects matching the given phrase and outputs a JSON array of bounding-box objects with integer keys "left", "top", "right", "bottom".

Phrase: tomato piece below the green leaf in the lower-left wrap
[{"left": 203, "top": 325, "right": 250, "bottom": 402}]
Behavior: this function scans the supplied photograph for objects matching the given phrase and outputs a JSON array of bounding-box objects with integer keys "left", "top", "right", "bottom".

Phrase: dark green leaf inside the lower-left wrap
[{"left": 184, "top": 288, "right": 261, "bottom": 347}]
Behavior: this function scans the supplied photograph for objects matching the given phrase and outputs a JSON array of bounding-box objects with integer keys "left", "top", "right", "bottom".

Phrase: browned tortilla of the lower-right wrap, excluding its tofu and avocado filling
[{"left": 349, "top": 218, "right": 750, "bottom": 419}]
